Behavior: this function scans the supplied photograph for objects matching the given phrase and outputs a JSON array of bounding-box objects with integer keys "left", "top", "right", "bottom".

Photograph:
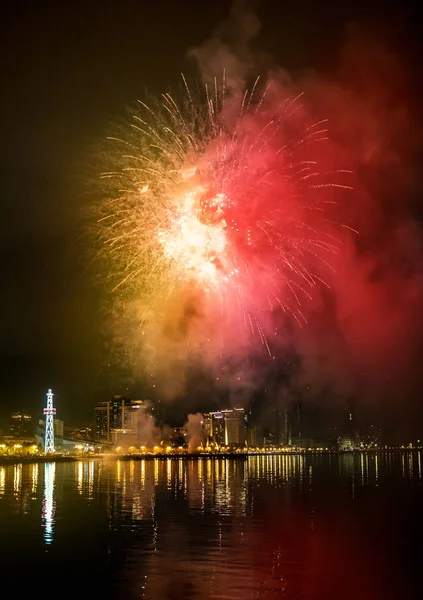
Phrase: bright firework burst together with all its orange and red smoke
[{"left": 94, "top": 3, "right": 423, "bottom": 432}]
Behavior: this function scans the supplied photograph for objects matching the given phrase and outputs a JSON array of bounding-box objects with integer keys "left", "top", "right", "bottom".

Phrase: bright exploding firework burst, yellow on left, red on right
[{"left": 98, "top": 75, "right": 349, "bottom": 353}]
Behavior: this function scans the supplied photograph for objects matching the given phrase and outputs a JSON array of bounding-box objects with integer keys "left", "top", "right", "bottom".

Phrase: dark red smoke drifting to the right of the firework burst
[{"left": 181, "top": 2, "right": 423, "bottom": 432}]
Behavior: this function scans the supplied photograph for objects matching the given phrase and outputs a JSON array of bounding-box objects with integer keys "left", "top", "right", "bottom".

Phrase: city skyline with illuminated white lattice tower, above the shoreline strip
[{"left": 0, "top": 389, "right": 423, "bottom": 455}]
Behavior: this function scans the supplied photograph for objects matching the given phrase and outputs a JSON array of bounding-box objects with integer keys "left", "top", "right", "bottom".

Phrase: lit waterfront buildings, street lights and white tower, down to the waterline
[{"left": 0, "top": 390, "right": 422, "bottom": 462}]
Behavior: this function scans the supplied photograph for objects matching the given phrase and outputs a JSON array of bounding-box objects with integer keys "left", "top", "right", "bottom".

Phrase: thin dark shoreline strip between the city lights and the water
[{"left": 0, "top": 448, "right": 423, "bottom": 466}]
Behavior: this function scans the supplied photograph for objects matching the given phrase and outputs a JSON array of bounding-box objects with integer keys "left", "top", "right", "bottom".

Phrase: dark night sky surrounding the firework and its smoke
[{"left": 0, "top": 0, "right": 418, "bottom": 428}]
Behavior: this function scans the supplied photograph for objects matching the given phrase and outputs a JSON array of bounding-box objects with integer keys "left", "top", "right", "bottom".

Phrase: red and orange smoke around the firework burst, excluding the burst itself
[{"left": 98, "top": 2, "right": 423, "bottom": 440}]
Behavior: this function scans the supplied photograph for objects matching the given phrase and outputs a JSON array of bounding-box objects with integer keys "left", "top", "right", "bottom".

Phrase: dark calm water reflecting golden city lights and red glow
[{"left": 0, "top": 452, "right": 423, "bottom": 600}]
